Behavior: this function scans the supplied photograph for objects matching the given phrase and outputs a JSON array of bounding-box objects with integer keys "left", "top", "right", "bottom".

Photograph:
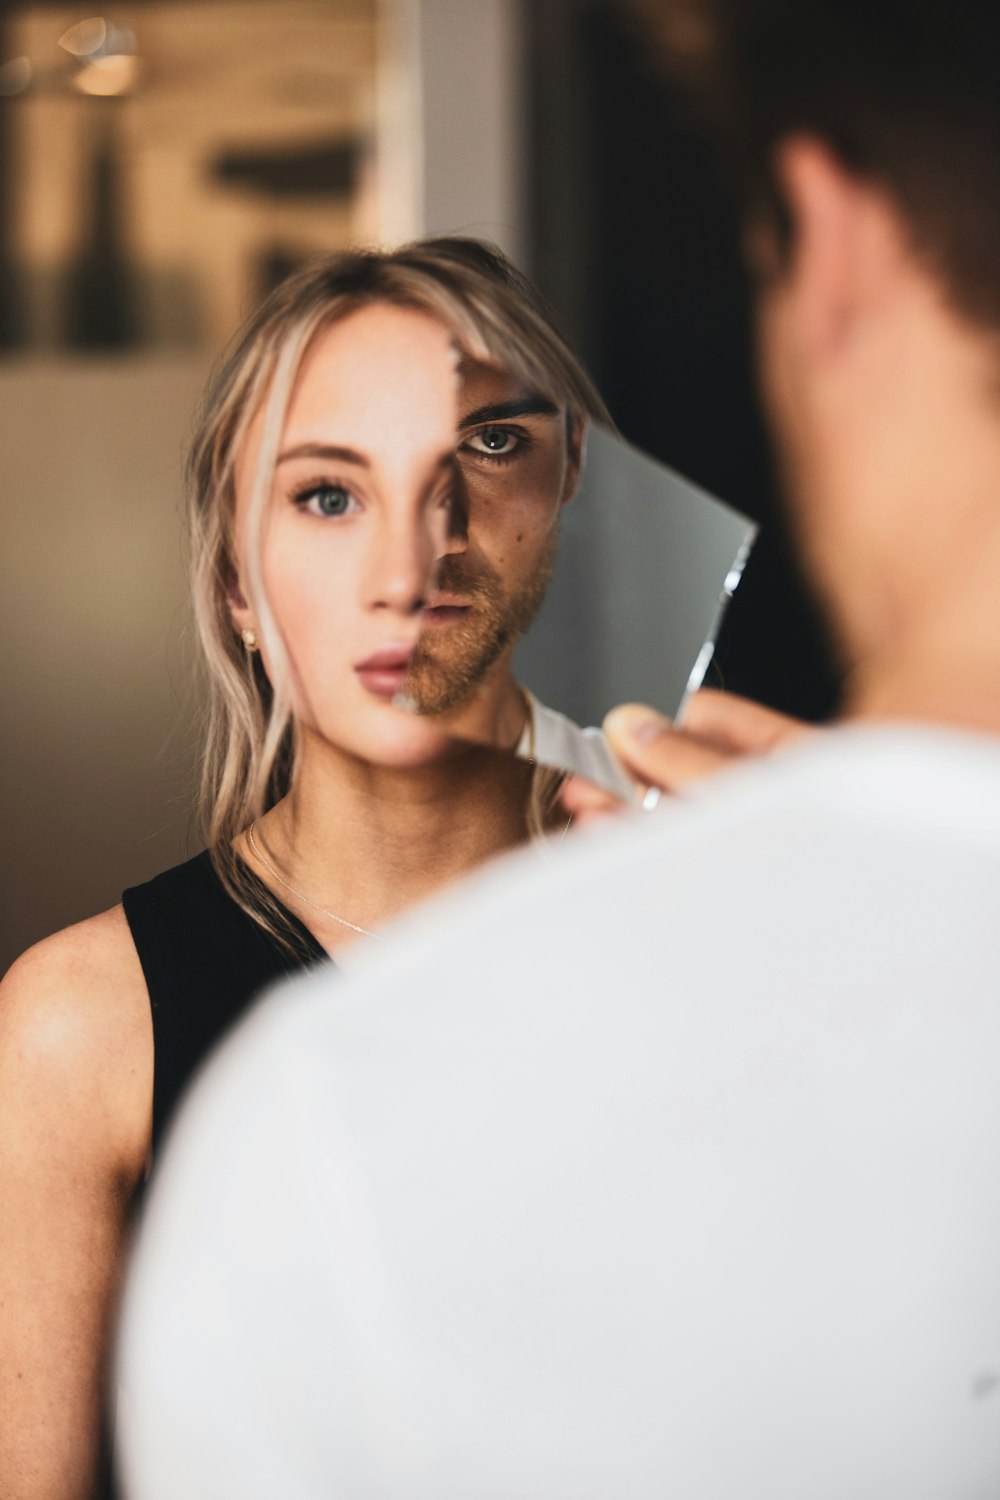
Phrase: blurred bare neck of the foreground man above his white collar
[{"left": 802, "top": 306, "right": 1000, "bottom": 734}]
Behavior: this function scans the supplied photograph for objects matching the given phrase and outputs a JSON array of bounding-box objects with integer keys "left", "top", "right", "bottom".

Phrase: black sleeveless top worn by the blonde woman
[{"left": 121, "top": 851, "right": 330, "bottom": 1160}]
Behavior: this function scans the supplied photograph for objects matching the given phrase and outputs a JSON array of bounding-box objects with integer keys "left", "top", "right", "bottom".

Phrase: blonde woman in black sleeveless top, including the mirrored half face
[{"left": 0, "top": 240, "right": 606, "bottom": 1500}]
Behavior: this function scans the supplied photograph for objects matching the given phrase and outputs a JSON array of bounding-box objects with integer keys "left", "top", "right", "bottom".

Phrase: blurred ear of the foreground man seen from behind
[{"left": 774, "top": 135, "right": 885, "bottom": 356}]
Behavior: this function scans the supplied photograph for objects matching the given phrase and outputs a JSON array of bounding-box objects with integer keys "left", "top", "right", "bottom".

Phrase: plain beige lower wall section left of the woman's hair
[{"left": 0, "top": 356, "right": 204, "bottom": 966}]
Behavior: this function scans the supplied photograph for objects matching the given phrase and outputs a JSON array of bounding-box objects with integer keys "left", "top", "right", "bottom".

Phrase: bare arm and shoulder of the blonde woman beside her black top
[{"left": 0, "top": 908, "right": 153, "bottom": 1500}]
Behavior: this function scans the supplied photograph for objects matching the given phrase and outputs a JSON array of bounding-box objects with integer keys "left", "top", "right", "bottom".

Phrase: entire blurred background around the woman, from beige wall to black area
[{"left": 0, "top": 0, "right": 837, "bottom": 965}]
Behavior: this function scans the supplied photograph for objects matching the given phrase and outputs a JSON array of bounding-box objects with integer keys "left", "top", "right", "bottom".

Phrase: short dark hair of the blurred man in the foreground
[{"left": 637, "top": 0, "right": 1000, "bottom": 327}]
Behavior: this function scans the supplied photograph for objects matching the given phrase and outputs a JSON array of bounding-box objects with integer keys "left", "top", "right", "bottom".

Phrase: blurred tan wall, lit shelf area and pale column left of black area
[{"left": 0, "top": 0, "right": 523, "bottom": 966}]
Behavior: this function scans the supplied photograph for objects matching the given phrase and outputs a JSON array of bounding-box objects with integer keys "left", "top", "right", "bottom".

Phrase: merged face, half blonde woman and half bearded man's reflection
[{"left": 231, "top": 303, "right": 580, "bottom": 767}]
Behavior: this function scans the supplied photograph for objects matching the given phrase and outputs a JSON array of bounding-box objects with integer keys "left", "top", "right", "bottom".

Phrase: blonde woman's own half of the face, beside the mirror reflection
[{"left": 229, "top": 303, "right": 457, "bottom": 765}]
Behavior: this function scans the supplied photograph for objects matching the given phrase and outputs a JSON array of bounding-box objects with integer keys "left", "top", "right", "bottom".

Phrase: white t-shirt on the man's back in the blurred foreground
[{"left": 121, "top": 728, "right": 1000, "bottom": 1500}]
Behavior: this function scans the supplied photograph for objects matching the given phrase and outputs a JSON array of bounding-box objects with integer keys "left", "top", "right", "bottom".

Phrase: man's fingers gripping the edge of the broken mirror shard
[{"left": 562, "top": 689, "right": 814, "bottom": 824}]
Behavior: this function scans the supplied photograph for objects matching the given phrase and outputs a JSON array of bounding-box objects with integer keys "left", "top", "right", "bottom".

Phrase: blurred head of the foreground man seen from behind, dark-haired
[{"left": 645, "top": 0, "right": 1000, "bottom": 660}]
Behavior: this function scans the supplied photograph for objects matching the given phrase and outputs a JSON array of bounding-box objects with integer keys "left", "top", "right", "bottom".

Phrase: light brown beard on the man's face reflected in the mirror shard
[{"left": 406, "top": 527, "right": 558, "bottom": 714}]
